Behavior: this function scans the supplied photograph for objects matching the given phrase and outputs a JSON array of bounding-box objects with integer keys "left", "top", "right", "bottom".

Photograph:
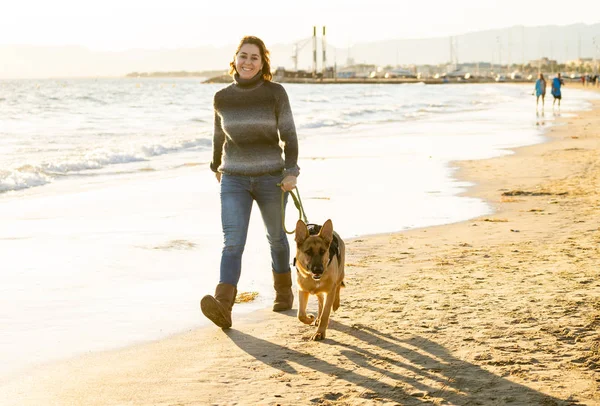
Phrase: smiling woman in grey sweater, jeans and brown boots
[{"left": 200, "top": 36, "right": 300, "bottom": 328}]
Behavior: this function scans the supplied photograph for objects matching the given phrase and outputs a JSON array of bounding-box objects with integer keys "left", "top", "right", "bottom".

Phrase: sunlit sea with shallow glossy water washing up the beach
[{"left": 0, "top": 78, "right": 598, "bottom": 380}]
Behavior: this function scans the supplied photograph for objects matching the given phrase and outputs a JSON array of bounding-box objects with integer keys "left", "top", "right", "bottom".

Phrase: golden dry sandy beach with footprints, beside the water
[{"left": 0, "top": 86, "right": 600, "bottom": 405}]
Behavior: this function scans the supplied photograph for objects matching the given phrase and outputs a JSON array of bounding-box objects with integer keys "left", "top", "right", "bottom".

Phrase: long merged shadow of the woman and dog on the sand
[{"left": 227, "top": 320, "right": 575, "bottom": 405}]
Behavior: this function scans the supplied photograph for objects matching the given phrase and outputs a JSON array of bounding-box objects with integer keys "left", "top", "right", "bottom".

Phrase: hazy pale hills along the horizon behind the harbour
[{"left": 0, "top": 23, "right": 600, "bottom": 78}]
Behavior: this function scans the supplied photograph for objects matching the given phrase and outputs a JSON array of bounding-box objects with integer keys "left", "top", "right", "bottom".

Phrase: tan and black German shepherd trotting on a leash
[{"left": 295, "top": 220, "right": 346, "bottom": 341}]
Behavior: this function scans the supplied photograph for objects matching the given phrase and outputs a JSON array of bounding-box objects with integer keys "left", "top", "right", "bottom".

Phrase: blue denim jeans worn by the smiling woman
[{"left": 219, "top": 174, "right": 290, "bottom": 286}]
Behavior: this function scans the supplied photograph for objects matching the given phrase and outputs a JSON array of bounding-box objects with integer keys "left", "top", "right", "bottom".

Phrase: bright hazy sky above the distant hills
[{"left": 0, "top": 0, "right": 600, "bottom": 51}]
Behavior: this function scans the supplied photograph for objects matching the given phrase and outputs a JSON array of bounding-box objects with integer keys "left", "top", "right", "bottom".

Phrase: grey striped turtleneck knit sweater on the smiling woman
[{"left": 210, "top": 73, "right": 300, "bottom": 176}]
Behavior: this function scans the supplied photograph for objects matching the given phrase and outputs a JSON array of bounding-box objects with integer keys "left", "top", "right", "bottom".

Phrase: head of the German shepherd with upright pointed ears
[{"left": 295, "top": 220, "right": 333, "bottom": 279}]
